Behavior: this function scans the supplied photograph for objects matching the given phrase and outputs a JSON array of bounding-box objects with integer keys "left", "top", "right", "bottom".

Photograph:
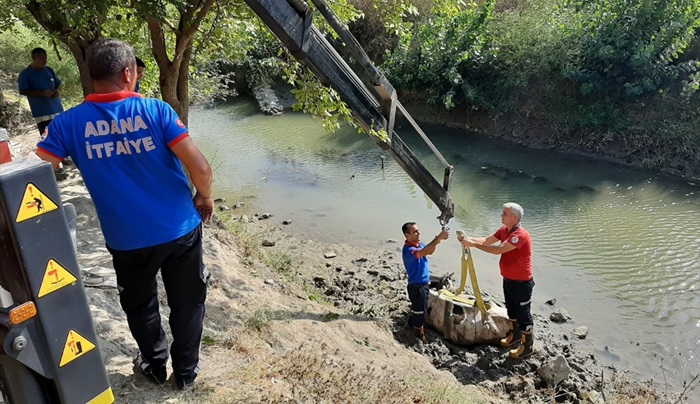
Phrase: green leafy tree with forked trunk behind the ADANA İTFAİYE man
[{"left": 0, "top": 0, "right": 394, "bottom": 126}]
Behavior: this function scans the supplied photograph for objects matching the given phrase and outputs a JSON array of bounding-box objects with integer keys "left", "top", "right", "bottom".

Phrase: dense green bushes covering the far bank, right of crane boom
[{"left": 374, "top": 0, "right": 700, "bottom": 167}]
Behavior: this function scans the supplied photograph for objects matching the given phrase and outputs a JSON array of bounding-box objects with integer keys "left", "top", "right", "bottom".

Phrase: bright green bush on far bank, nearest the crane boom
[{"left": 385, "top": 0, "right": 496, "bottom": 109}]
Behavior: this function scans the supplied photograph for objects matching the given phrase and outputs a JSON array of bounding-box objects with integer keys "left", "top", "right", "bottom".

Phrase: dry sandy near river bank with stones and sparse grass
[{"left": 2, "top": 126, "right": 688, "bottom": 403}]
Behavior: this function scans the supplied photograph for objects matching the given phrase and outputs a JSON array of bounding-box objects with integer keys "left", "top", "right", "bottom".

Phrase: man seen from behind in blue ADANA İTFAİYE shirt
[{"left": 37, "top": 39, "right": 214, "bottom": 389}]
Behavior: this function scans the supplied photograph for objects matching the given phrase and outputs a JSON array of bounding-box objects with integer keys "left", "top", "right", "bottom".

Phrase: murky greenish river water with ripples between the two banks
[{"left": 190, "top": 101, "right": 700, "bottom": 392}]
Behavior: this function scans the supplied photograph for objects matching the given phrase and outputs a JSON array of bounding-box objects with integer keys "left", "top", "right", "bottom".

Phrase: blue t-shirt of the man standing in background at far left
[{"left": 17, "top": 66, "right": 63, "bottom": 121}]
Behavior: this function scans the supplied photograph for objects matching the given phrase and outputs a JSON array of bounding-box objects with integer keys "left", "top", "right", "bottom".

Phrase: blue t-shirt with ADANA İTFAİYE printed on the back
[{"left": 38, "top": 92, "right": 201, "bottom": 250}]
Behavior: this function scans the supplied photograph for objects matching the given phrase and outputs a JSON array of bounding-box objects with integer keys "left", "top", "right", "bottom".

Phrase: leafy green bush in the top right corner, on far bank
[{"left": 562, "top": 0, "right": 700, "bottom": 101}]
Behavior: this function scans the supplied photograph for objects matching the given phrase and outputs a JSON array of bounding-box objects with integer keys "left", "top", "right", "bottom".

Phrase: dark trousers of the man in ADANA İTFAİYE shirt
[{"left": 108, "top": 225, "right": 209, "bottom": 384}]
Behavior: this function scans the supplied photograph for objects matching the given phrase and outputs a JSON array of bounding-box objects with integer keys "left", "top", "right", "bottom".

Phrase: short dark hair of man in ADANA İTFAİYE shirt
[{"left": 87, "top": 39, "right": 136, "bottom": 80}]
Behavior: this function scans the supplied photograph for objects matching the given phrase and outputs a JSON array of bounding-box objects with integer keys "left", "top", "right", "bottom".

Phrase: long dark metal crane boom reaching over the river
[{"left": 245, "top": 0, "right": 454, "bottom": 225}]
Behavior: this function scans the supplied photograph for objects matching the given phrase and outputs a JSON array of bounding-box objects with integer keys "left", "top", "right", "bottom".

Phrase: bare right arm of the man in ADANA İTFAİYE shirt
[{"left": 170, "top": 136, "right": 214, "bottom": 223}]
